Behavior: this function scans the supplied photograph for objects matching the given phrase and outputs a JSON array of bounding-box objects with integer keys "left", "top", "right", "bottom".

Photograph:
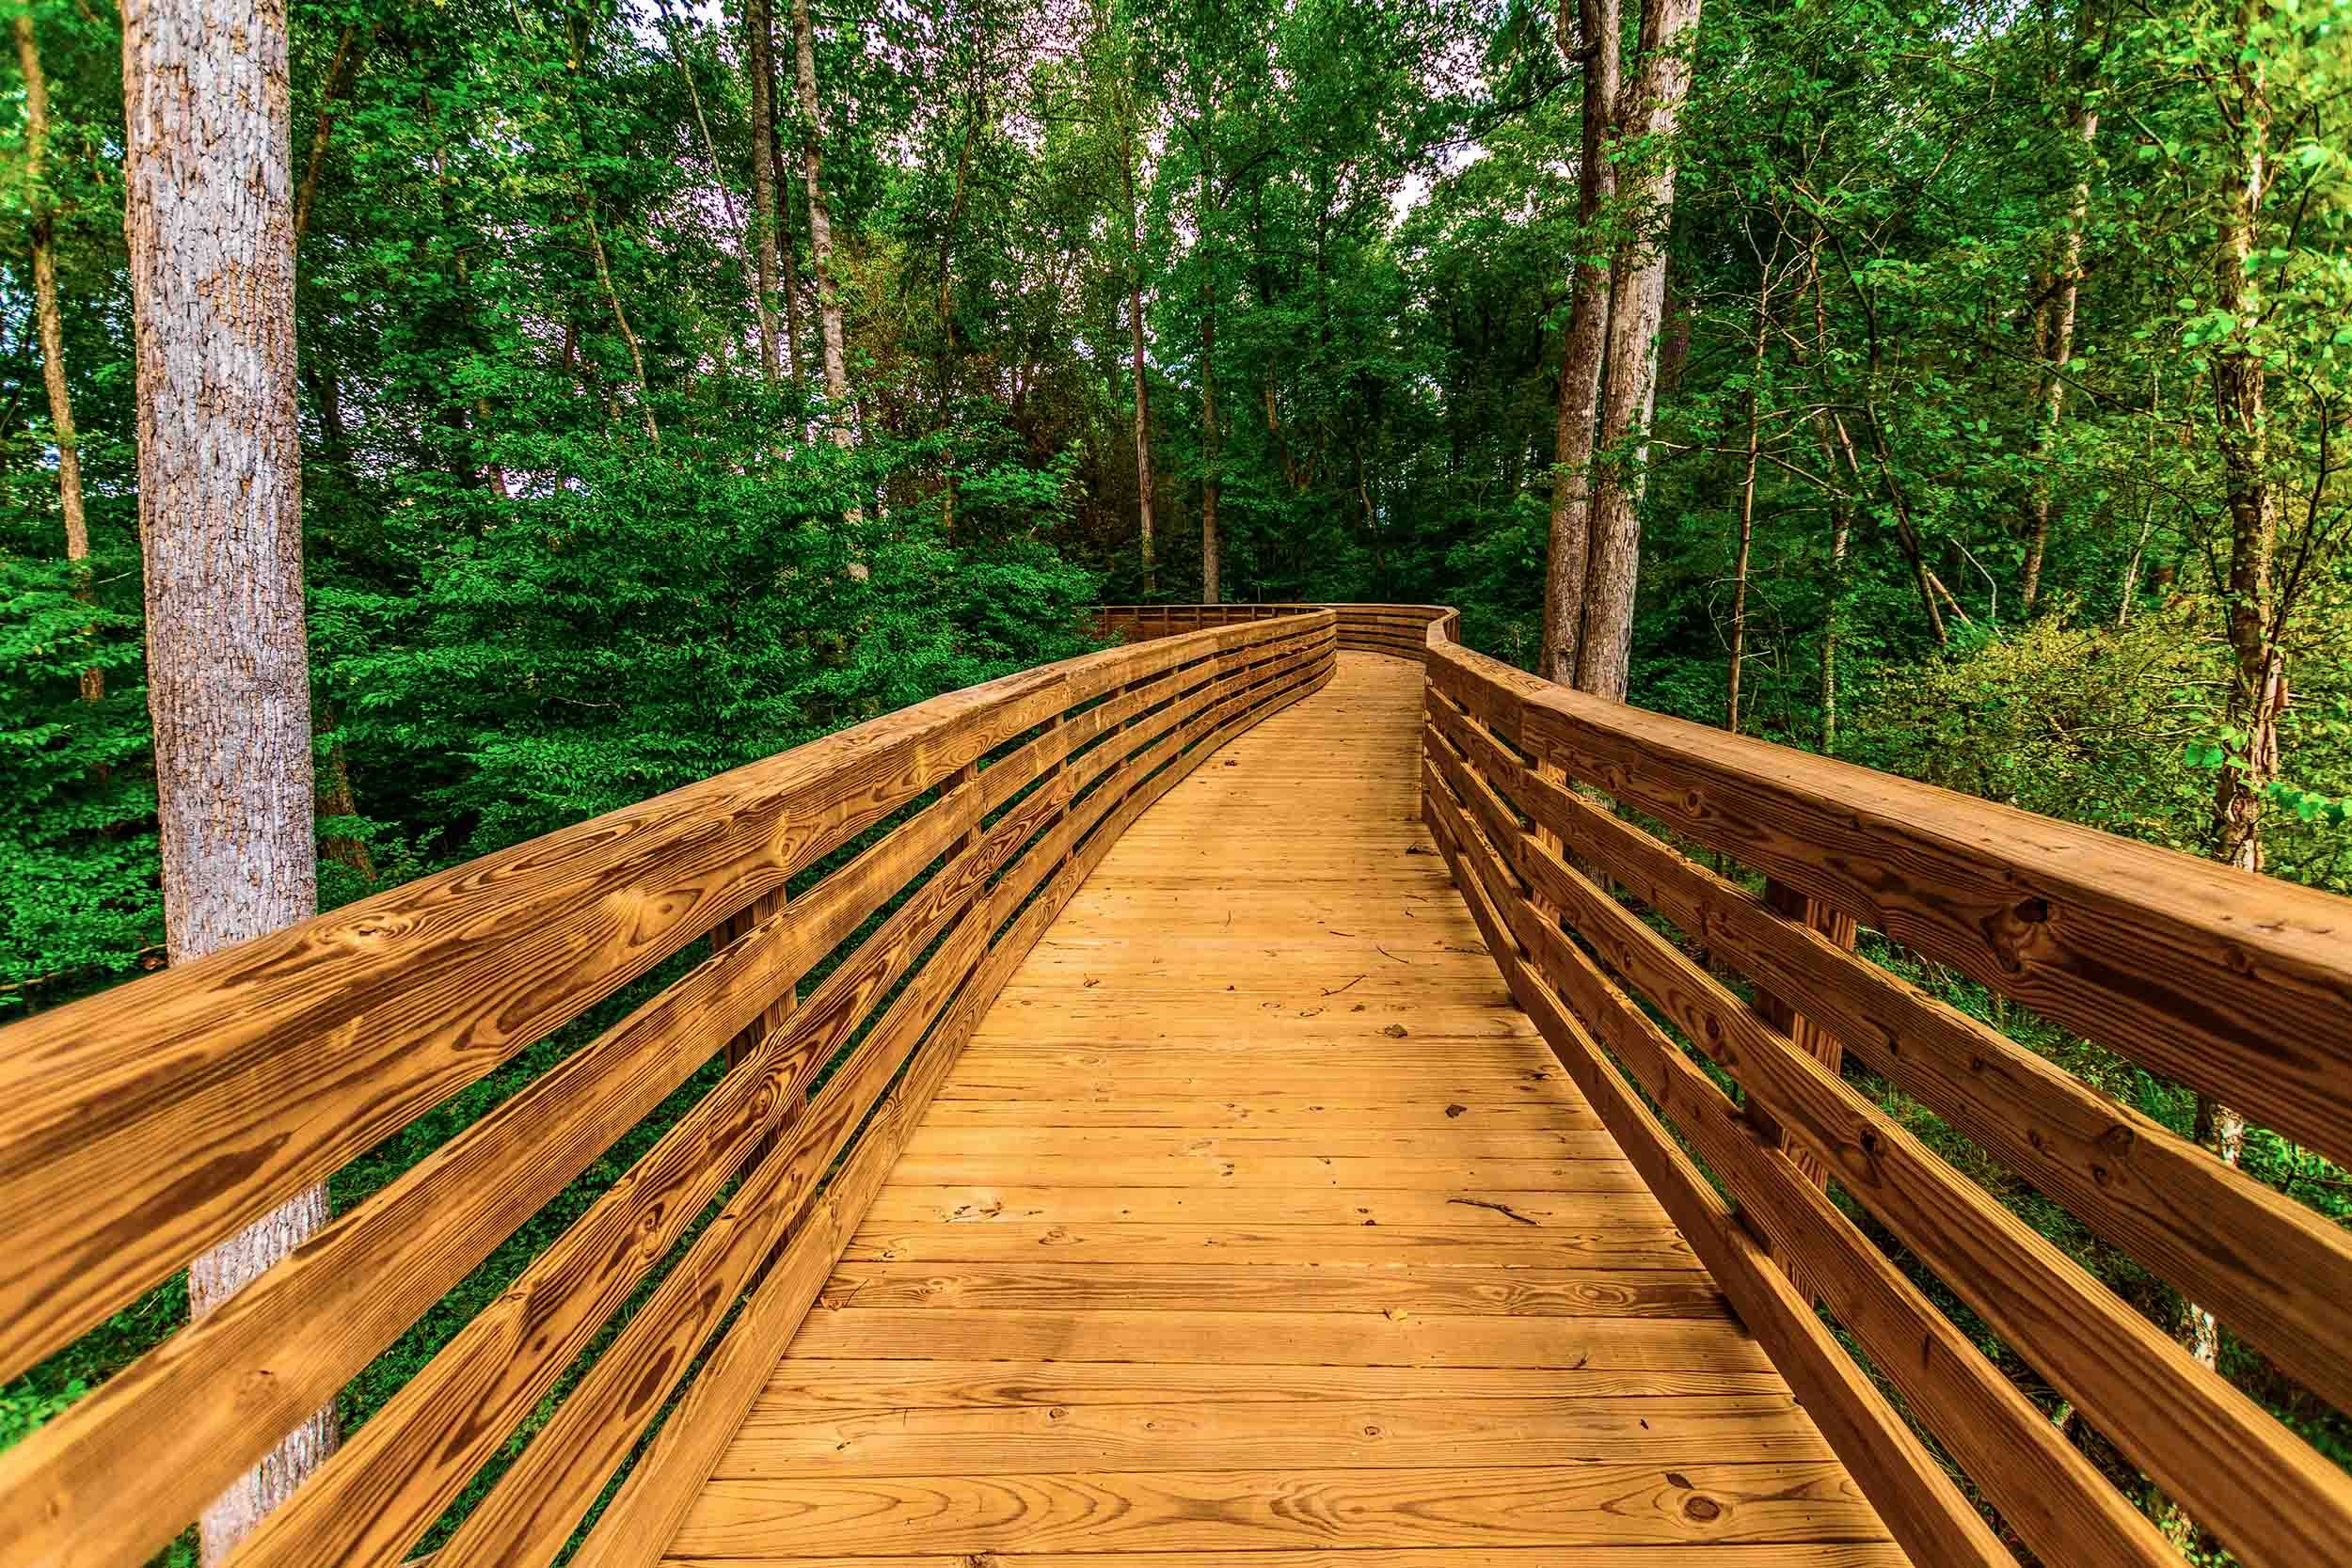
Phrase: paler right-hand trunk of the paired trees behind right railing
[{"left": 1576, "top": 0, "right": 1698, "bottom": 701}]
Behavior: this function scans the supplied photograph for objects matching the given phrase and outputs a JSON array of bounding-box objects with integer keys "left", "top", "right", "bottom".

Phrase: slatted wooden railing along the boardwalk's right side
[{"left": 1423, "top": 610, "right": 2352, "bottom": 1568}]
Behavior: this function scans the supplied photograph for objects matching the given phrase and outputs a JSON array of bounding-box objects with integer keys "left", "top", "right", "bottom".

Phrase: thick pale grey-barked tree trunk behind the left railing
[{"left": 122, "top": 0, "right": 334, "bottom": 1563}]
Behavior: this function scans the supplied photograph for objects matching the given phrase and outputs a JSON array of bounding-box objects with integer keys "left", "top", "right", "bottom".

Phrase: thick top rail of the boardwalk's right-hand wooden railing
[{"left": 1433, "top": 649, "right": 2352, "bottom": 1164}]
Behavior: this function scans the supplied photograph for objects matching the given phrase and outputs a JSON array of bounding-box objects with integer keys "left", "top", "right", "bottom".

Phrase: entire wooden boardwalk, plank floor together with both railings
[{"left": 0, "top": 604, "right": 2352, "bottom": 1568}]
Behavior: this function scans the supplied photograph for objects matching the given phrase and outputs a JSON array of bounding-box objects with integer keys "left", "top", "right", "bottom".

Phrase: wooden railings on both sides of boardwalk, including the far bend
[{"left": 0, "top": 604, "right": 2352, "bottom": 1568}]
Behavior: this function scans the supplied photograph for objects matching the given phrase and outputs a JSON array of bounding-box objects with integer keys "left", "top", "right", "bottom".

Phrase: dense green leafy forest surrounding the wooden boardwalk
[{"left": 0, "top": 0, "right": 2352, "bottom": 1549}]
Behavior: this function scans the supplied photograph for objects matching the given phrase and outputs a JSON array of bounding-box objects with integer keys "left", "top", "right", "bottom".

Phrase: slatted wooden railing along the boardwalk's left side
[{"left": 0, "top": 611, "right": 1339, "bottom": 1568}]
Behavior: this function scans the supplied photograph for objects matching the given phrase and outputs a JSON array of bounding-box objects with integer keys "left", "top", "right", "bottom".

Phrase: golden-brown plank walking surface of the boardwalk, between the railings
[{"left": 671, "top": 654, "right": 1903, "bottom": 1568}]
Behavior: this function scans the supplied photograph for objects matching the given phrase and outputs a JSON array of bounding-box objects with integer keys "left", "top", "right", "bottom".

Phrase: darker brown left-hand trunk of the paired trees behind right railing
[{"left": 1538, "top": 0, "right": 1621, "bottom": 687}]
